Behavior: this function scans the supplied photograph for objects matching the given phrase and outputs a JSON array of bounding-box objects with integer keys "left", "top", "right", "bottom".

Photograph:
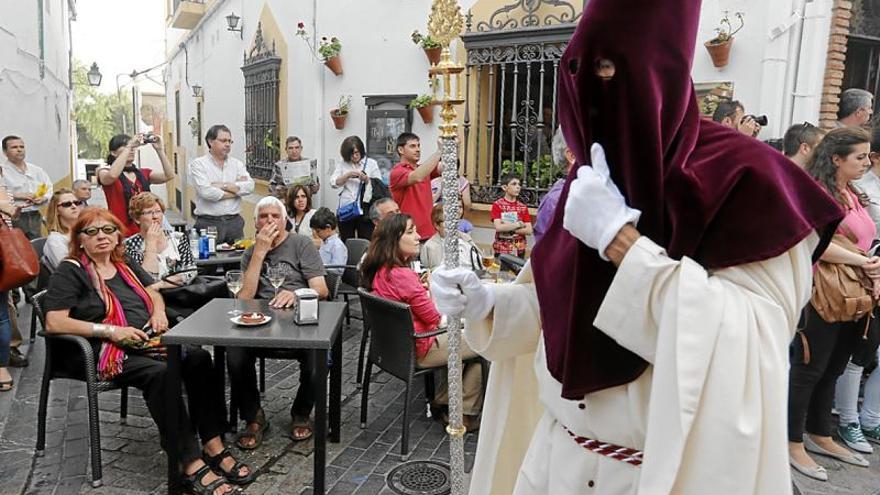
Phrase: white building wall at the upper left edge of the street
[{"left": 0, "top": 0, "right": 72, "bottom": 181}]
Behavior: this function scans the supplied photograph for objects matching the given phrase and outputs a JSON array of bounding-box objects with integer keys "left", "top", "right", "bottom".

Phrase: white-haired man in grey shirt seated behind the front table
[{"left": 226, "top": 196, "right": 328, "bottom": 450}]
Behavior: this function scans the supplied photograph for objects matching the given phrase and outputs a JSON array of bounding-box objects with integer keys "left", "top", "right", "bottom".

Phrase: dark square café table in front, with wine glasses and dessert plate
[{"left": 162, "top": 298, "right": 345, "bottom": 494}]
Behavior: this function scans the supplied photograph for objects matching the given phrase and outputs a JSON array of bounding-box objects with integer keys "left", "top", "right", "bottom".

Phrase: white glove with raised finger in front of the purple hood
[{"left": 562, "top": 143, "right": 642, "bottom": 261}]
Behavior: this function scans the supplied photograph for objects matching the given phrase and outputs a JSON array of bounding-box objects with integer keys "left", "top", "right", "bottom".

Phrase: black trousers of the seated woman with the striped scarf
[{"left": 113, "top": 347, "right": 226, "bottom": 466}]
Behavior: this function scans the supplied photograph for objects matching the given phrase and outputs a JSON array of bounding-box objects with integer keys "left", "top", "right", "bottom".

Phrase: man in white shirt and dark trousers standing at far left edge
[{"left": 3, "top": 136, "right": 52, "bottom": 239}]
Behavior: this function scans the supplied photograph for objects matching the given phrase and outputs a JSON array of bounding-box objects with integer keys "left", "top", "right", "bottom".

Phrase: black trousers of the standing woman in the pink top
[{"left": 788, "top": 305, "right": 865, "bottom": 442}]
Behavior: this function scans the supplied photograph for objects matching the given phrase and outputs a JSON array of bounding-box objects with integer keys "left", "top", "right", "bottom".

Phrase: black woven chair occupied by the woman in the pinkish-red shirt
[{"left": 358, "top": 289, "right": 488, "bottom": 457}]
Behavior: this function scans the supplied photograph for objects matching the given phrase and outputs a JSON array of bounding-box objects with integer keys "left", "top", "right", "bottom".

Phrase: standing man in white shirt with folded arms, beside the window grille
[{"left": 188, "top": 124, "right": 254, "bottom": 243}]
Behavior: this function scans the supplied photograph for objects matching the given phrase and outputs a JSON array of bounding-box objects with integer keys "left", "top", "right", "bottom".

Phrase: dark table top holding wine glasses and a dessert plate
[{"left": 162, "top": 298, "right": 345, "bottom": 350}]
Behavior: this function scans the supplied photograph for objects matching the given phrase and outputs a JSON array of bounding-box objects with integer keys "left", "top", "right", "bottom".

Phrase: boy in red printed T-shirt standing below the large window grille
[{"left": 492, "top": 174, "right": 532, "bottom": 258}]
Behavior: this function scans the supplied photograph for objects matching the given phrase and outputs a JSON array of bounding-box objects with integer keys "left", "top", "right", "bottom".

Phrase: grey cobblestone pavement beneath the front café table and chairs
[{"left": 0, "top": 307, "right": 477, "bottom": 495}]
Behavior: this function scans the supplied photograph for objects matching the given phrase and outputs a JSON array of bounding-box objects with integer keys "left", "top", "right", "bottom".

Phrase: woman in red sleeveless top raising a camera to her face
[{"left": 98, "top": 133, "right": 174, "bottom": 237}]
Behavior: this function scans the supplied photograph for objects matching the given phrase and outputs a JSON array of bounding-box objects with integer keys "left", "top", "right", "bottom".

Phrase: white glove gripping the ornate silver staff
[{"left": 431, "top": 265, "right": 495, "bottom": 320}]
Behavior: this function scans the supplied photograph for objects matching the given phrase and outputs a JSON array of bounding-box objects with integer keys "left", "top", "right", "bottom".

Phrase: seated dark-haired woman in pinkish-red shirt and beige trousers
[{"left": 361, "top": 213, "right": 482, "bottom": 431}]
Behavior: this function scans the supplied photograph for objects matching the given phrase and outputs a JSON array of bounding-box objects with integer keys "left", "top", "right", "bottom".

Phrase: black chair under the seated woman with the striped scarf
[{"left": 33, "top": 290, "right": 128, "bottom": 488}]
